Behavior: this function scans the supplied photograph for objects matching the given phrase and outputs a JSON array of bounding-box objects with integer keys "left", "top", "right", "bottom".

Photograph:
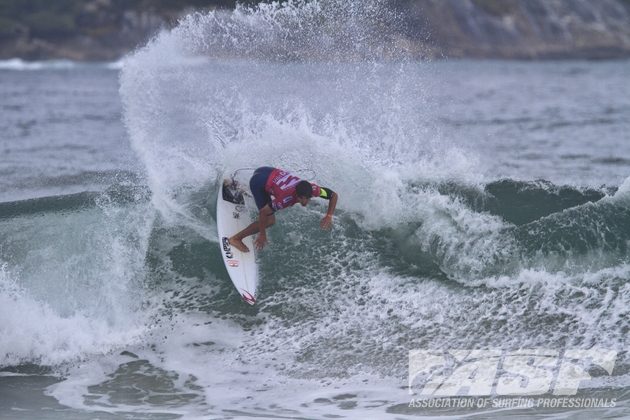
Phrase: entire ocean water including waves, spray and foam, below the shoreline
[{"left": 0, "top": 2, "right": 630, "bottom": 419}]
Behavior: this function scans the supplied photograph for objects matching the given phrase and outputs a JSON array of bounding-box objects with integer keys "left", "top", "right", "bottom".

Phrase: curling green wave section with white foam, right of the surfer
[{"left": 383, "top": 179, "right": 630, "bottom": 285}]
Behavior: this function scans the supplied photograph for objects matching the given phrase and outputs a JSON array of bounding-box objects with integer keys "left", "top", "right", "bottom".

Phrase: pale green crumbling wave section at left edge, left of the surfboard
[{"left": 0, "top": 188, "right": 151, "bottom": 366}]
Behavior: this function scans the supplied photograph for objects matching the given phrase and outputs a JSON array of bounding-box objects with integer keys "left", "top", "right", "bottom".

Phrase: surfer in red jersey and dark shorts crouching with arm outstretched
[{"left": 230, "top": 166, "right": 338, "bottom": 252}]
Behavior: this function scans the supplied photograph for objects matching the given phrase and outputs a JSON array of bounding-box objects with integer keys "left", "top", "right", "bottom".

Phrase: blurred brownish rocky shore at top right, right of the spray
[{"left": 400, "top": 0, "right": 630, "bottom": 58}]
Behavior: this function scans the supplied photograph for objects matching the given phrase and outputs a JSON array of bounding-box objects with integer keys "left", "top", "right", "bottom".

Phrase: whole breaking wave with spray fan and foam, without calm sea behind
[{"left": 0, "top": 1, "right": 630, "bottom": 417}]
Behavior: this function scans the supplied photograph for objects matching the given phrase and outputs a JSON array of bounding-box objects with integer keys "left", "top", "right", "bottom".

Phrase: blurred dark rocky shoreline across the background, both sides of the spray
[{"left": 0, "top": 0, "right": 630, "bottom": 62}]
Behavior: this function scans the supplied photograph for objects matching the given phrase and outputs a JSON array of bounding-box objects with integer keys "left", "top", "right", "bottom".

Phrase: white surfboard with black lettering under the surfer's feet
[{"left": 217, "top": 178, "right": 258, "bottom": 305}]
